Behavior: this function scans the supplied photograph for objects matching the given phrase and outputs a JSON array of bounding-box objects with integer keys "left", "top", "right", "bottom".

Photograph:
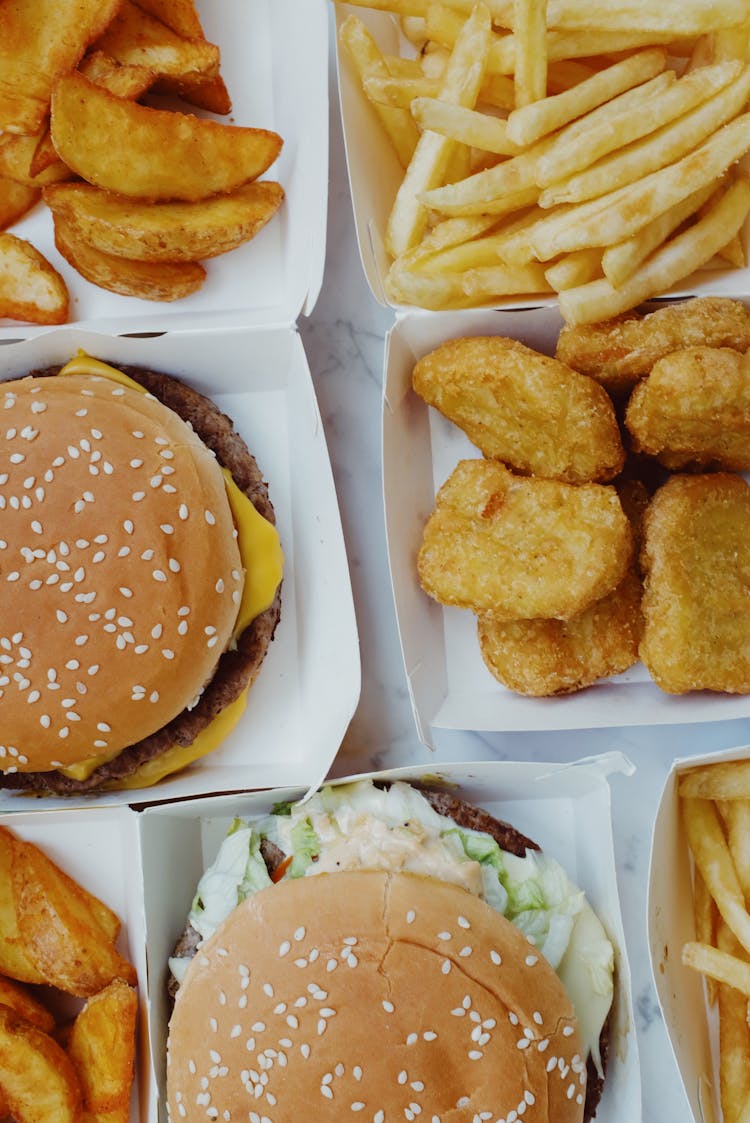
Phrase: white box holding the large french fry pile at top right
[{"left": 336, "top": 3, "right": 750, "bottom": 313}]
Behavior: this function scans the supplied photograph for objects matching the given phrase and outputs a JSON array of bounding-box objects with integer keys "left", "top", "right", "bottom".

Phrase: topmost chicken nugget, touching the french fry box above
[{"left": 557, "top": 296, "right": 750, "bottom": 393}]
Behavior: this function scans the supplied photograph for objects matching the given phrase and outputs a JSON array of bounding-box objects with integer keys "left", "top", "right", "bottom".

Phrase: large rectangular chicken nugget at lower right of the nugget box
[{"left": 640, "top": 472, "right": 750, "bottom": 694}]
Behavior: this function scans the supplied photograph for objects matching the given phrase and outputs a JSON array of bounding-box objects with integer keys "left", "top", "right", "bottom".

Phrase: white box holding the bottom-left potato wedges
[{"left": 0, "top": 807, "right": 155, "bottom": 1121}]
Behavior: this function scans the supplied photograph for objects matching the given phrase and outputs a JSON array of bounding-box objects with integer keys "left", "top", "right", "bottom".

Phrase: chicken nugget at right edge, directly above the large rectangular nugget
[{"left": 625, "top": 347, "right": 750, "bottom": 472}]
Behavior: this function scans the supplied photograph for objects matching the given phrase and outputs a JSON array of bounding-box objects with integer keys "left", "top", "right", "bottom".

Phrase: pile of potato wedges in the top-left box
[{"left": 0, "top": 0, "right": 284, "bottom": 323}]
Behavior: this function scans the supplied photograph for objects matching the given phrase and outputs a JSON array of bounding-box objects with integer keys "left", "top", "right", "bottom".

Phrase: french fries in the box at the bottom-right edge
[{"left": 678, "top": 760, "right": 750, "bottom": 1123}]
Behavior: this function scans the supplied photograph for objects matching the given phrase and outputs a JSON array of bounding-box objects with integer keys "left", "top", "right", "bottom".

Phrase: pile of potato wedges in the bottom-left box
[{"left": 0, "top": 828, "right": 138, "bottom": 1123}]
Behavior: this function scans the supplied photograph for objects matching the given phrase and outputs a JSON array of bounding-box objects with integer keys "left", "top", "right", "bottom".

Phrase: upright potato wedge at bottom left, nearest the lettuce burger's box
[{"left": 66, "top": 979, "right": 138, "bottom": 1121}]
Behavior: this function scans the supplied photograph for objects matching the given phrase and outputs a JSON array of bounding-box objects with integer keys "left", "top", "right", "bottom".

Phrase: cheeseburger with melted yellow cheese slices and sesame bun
[{"left": 0, "top": 354, "right": 282, "bottom": 794}]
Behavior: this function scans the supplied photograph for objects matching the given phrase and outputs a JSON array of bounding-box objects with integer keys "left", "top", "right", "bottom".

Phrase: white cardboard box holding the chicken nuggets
[{"left": 383, "top": 309, "right": 750, "bottom": 745}]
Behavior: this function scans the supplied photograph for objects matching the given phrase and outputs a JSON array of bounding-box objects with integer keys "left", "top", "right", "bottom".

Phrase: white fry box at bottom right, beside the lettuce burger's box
[{"left": 648, "top": 746, "right": 750, "bottom": 1123}]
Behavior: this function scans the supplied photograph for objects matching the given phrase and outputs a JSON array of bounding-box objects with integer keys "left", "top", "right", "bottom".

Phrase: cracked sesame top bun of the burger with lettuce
[{"left": 167, "top": 871, "right": 586, "bottom": 1123}]
